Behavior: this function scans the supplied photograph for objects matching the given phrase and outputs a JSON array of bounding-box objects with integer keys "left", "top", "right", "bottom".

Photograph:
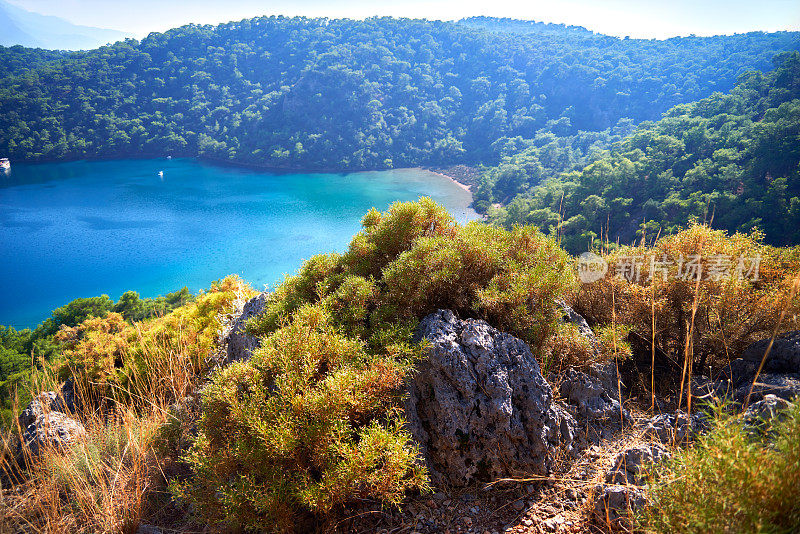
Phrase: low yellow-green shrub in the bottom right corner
[{"left": 641, "top": 403, "right": 800, "bottom": 533}]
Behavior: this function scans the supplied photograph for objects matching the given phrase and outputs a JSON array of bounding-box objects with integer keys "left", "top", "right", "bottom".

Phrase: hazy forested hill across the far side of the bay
[{"left": 0, "top": 17, "right": 800, "bottom": 171}]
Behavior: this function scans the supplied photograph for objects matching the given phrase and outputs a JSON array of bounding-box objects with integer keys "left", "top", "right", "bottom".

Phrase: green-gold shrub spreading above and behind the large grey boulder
[{"left": 250, "top": 198, "right": 575, "bottom": 358}]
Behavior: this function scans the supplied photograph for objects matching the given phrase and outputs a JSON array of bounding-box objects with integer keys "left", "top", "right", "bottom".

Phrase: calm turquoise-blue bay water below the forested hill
[{"left": 0, "top": 159, "right": 475, "bottom": 328}]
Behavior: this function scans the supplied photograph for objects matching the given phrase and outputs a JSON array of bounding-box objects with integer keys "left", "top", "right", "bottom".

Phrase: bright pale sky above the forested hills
[{"left": 7, "top": 0, "right": 800, "bottom": 38}]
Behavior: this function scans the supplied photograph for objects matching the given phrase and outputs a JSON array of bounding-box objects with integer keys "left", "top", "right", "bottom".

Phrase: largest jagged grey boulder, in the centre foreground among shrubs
[{"left": 406, "top": 310, "right": 575, "bottom": 486}]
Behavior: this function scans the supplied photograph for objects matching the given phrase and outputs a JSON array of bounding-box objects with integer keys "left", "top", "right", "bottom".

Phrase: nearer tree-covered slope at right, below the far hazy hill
[{"left": 480, "top": 52, "right": 800, "bottom": 252}]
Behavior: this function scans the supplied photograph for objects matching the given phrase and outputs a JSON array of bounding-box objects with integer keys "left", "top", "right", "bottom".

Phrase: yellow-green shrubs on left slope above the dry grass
[{"left": 55, "top": 276, "right": 253, "bottom": 405}]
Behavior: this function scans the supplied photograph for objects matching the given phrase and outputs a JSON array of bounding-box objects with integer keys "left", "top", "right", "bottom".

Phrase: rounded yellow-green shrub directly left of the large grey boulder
[{"left": 176, "top": 304, "right": 427, "bottom": 531}]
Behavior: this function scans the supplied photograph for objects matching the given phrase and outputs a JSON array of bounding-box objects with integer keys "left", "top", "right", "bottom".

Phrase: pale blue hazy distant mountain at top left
[{"left": 0, "top": 0, "right": 130, "bottom": 50}]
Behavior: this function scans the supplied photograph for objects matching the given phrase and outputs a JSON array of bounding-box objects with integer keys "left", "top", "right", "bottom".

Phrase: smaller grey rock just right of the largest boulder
[{"left": 559, "top": 362, "right": 631, "bottom": 424}]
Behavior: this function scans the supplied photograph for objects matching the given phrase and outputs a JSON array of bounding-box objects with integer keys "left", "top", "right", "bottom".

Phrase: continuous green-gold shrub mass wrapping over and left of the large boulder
[{"left": 184, "top": 199, "right": 575, "bottom": 531}]
